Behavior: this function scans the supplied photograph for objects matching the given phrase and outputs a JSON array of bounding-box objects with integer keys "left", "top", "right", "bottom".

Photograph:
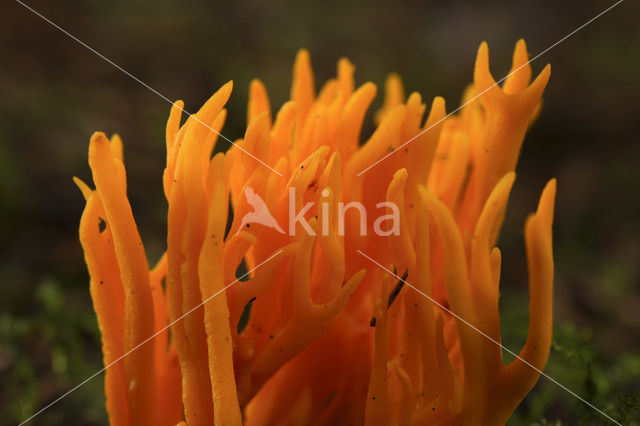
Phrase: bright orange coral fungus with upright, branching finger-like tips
[{"left": 76, "top": 41, "right": 555, "bottom": 426}]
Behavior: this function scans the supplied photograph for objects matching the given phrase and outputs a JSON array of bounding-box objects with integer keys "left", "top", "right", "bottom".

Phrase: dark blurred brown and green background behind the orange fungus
[{"left": 0, "top": 0, "right": 640, "bottom": 425}]
